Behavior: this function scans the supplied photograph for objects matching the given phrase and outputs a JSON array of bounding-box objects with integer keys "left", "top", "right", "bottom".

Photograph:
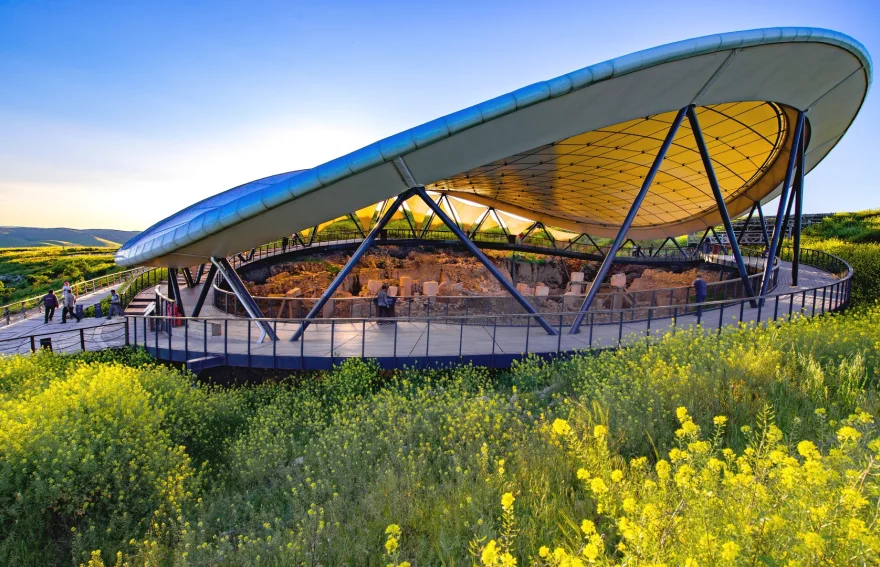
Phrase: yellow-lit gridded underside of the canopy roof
[{"left": 427, "top": 102, "right": 788, "bottom": 233}]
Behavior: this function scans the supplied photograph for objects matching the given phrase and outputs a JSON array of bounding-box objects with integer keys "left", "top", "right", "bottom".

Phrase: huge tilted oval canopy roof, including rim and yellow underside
[{"left": 116, "top": 28, "right": 872, "bottom": 267}]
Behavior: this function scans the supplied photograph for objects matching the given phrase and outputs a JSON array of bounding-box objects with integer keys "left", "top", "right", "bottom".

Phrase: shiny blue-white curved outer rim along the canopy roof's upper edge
[{"left": 116, "top": 27, "right": 873, "bottom": 266}]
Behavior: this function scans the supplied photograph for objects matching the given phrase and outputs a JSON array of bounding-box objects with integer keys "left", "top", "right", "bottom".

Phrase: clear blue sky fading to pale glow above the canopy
[{"left": 0, "top": 0, "right": 880, "bottom": 230}]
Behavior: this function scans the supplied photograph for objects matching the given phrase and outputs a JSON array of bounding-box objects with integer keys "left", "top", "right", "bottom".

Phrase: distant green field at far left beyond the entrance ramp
[{"left": 0, "top": 246, "right": 122, "bottom": 303}]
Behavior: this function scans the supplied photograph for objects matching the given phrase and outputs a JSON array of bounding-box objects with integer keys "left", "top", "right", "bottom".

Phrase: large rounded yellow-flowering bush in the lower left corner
[{"left": 0, "top": 364, "right": 193, "bottom": 565}]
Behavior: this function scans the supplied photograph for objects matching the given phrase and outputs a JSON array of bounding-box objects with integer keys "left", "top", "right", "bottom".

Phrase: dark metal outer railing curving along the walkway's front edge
[{"left": 111, "top": 246, "right": 852, "bottom": 369}]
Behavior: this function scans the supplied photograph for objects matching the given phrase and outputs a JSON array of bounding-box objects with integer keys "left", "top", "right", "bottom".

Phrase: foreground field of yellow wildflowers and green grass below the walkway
[{"left": 0, "top": 243, "right": 880, "bottom": 567}]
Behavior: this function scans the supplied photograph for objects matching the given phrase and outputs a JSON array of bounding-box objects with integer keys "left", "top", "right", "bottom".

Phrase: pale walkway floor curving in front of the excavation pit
[{"left": 124, "top": 256, "right": 839, "bottom": 367}]
